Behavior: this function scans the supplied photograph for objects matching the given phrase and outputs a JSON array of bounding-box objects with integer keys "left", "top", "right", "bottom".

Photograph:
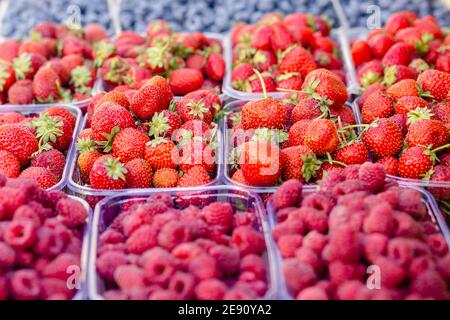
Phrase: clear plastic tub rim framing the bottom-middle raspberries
[{"left": 87, "top": 186, "right": 279, "bottom": 300}]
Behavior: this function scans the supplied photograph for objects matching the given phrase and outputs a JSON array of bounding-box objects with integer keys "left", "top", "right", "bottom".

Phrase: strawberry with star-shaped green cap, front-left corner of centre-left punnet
[{"left": 89, "top": 155, "right": 128, "bottom": 189}]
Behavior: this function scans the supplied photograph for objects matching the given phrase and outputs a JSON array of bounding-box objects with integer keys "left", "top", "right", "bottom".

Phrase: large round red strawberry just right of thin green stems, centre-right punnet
[{"left": 363, "top": 119, "right": 403, "bottom": 158}]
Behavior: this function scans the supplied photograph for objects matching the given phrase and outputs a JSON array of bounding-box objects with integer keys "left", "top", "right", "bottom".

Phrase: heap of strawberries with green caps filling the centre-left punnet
[{"left": 77, "top": 76, "right": 222, "bottom": 189}]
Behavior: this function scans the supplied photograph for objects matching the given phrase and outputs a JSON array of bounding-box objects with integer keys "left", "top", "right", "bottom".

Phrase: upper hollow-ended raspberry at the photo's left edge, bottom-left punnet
[{"left": 3, "top": 219, "right": 36, "bottom": 249}]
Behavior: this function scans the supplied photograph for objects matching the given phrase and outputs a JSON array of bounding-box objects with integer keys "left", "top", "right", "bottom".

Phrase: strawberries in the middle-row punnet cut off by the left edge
[{"left": 0, "top": 106, "right": 76, "bottom": 189}]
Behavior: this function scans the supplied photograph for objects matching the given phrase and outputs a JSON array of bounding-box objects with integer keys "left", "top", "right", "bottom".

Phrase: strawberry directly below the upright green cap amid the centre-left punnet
[{"left": 144, "top": 138, "right": 179, "bottom": 170}]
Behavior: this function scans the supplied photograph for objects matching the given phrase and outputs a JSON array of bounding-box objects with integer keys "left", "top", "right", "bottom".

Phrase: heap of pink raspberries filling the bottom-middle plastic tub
[{"left": 96, "top": 193, "right": 267, "bottom": 300}]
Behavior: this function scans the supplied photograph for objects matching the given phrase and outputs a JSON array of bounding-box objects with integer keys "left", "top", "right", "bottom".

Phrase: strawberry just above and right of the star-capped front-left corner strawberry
[{"left": 112, "top": 128, "right": 150, "bottom": 163}]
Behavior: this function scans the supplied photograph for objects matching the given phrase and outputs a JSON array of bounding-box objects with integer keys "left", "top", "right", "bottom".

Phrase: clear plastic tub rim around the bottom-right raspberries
[{"left": 267, "top": 183, "right": 450, "bottom": 299}]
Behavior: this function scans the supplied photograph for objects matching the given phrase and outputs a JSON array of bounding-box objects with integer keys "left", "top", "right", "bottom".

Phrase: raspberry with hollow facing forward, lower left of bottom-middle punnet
[{"left": 139, "top": 248, "right": 175, "bottom": 285}]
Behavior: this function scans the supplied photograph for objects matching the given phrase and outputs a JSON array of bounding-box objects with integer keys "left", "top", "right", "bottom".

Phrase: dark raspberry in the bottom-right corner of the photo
[{"left": 409, "top": 270, "right": 449, "bottom": 300}]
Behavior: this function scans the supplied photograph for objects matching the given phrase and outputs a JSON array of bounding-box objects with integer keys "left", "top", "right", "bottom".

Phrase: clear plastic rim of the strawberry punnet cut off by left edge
[{"left": 0, "top": 104, "right": 82, "bottom": 190}]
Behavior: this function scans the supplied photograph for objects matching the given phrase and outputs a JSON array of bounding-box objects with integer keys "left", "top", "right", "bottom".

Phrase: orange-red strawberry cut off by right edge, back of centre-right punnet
[{"left": 417, "top": 70, "right": 450, "bottom": 101}]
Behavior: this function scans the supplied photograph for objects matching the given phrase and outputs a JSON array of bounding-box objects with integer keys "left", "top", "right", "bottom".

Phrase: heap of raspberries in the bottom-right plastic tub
[{"left": 272, "top": 163, "right": 450, "bottom": 300}]
